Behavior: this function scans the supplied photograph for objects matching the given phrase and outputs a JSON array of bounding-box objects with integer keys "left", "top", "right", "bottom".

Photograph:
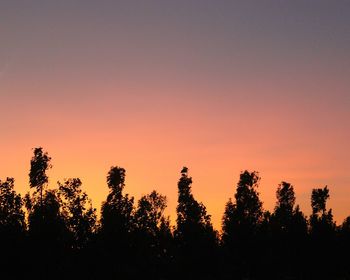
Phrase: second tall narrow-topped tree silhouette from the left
[{"left": 99, "top": 166, "right": 135, "bottom": 278}]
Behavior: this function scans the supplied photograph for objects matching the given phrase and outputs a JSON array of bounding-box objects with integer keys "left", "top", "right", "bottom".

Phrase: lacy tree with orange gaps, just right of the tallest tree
[{"left": 58, "top": 178, "right": 96, "bottom": 249}]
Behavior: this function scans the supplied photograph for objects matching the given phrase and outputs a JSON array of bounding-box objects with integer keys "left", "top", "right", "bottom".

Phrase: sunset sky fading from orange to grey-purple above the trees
[{"left": 0, "top": 0, "right": 350, "bottom": 229}]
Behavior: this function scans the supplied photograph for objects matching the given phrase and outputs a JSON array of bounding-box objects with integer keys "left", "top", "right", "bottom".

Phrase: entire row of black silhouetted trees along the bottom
[{"left": 0, "top": 147, "right": 350, "bottom": 279}]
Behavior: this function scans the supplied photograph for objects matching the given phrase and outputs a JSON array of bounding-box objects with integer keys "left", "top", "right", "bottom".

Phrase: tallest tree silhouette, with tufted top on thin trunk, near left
[{"left": 24, "top": 147, "right": 68, "bottom": 278}]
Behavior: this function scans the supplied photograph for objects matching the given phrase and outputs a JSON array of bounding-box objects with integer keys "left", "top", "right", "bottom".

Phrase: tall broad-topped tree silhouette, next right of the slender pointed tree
[{"left": 222, "top": 170, "right": 263, "bottom": 277}]
